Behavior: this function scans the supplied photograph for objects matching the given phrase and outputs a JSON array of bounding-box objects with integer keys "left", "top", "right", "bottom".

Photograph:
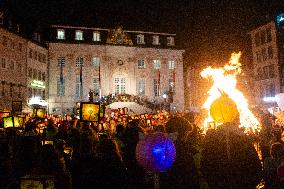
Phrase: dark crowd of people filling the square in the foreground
[{"left": 0, "top": 108, "right": 284, "bottom": 189}]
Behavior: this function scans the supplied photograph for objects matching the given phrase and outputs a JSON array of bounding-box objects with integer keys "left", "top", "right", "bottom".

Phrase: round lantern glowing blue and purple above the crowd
[{"left": 136, "top": 132, "right": 176, "bottom": 172}]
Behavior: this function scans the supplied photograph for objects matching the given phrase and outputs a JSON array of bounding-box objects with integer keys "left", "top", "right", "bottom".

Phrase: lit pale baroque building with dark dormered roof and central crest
[{"left": 48, "top": 25, "right": 184, "bottom": 113}]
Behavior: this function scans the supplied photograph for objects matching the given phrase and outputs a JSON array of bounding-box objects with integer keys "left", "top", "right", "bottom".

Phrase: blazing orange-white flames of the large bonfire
[{"left": 201, "top": 52, "right": 260, "bottom": 133}]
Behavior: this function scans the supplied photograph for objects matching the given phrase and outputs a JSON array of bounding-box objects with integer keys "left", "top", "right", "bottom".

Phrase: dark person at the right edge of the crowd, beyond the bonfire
[{"left": 264, "top": 142, "right": 284, "bottom": 189}]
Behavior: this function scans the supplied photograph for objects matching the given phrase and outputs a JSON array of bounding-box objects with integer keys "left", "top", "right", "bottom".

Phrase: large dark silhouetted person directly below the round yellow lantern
[{"left": 201, "top": 116, "right": 262, "bottom": 189}]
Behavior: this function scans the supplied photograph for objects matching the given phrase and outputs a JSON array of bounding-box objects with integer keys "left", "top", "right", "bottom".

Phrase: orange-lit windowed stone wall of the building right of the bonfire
[{"left": 251, "top": 21, "right": 281, "bottom": 106}]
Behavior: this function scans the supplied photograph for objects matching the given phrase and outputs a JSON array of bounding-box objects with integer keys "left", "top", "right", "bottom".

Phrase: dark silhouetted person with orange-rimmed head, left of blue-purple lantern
[{"left": 81, "top": 138, "right": 128, "bottom": 189}]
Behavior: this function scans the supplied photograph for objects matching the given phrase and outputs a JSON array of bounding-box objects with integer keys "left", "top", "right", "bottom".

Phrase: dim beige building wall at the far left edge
[{"left": 0, "top": 28, "right": 27, "bottom": 110}]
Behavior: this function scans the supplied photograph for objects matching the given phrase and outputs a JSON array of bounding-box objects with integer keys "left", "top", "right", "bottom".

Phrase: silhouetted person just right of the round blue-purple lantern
[{"left": 160, "top": 117, "right": 199, "bottom": 189}]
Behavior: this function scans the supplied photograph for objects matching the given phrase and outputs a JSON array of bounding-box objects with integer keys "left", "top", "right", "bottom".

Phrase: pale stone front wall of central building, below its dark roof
[{"left": 49, "top": 43, "right": 184, "bottom": 113}]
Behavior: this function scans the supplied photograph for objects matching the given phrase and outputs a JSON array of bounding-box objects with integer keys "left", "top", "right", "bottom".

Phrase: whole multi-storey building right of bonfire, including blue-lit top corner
[{"left": 250, "top": 14, "right": 284, "bottom": 108}]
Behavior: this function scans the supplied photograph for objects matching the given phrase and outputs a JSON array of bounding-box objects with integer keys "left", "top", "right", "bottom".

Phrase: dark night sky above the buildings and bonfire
[{"left": 3, "top": 0, "right": 284, "bottom": 67}]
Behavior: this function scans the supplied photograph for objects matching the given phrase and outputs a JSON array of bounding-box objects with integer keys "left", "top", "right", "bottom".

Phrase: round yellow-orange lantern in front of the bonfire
[{"left": 210, "top": 94, "right": 239, "bottom": 123}]
